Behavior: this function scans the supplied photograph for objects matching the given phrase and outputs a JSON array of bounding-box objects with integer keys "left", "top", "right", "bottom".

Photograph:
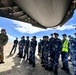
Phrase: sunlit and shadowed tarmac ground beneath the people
[{"left": 0, "top": 43, "right": 73, "bottom": 75}]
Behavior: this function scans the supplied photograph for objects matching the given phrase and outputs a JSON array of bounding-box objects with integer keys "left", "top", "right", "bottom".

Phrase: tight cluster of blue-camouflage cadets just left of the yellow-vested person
[{"left": 38, "top": 33, "right": 62, "bottom": 74}]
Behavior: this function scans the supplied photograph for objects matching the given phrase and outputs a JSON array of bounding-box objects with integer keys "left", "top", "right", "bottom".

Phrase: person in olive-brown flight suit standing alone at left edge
[{"left": 0, "top": 29, "right": 8, "bottom": 64}]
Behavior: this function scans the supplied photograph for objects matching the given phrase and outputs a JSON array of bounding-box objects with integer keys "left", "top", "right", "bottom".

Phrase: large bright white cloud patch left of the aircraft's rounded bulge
[{"left": 13, "top": 20, "right": 45, "bottom": 34}]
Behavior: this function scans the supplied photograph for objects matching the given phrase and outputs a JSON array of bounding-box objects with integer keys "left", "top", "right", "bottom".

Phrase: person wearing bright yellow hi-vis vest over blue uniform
[{"left": 61, "top": 34, "right": 70, "bottom": 74}]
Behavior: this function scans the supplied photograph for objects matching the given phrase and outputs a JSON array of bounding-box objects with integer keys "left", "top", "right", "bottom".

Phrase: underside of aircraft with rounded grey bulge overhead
[{"left": 0, "top": 0, "right": 76, "bottom": 28}]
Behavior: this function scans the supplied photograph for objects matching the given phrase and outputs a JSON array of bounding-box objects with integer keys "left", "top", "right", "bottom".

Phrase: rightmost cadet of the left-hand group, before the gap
[{"left": 29, "top": 36, "right": 37, "bottom": 67}]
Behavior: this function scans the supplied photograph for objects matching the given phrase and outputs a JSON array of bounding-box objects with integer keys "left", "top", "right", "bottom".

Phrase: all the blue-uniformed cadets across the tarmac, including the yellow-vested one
[{"left": 10, "top": 33, "right": 76, "bottom": 75}]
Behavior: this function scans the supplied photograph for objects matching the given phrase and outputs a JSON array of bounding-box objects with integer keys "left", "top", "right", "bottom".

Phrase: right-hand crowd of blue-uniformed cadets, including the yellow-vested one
[{"left": 38, "top": 33, "right": 76, "bottom": 75}]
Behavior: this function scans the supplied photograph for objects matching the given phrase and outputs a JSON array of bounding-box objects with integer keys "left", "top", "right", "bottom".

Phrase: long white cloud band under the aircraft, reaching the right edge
[{"left": 13, "top": 20, "right": 76, "bottom": 34}]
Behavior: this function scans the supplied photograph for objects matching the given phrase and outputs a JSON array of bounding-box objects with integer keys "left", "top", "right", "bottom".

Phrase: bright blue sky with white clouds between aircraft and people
[{"left": 0, "top": 10, "right": 76, "bottom": 42}]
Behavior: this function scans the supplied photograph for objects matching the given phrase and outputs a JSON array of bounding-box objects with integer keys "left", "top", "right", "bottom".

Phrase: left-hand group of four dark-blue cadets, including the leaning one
[{"left": 10, "top": 36, "right": 37, "bottom": 67}]
